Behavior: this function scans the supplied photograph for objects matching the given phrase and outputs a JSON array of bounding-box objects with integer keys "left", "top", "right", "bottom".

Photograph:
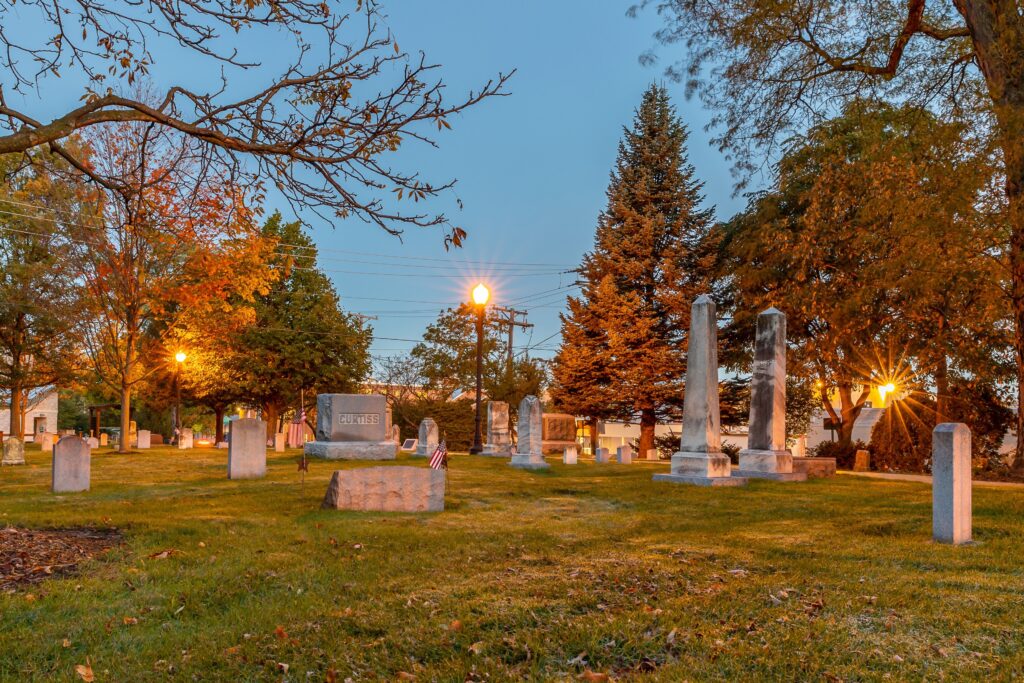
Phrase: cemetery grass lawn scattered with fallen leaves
[{"left": 0, "top": 446, "right": 1024, "bottom": 681}]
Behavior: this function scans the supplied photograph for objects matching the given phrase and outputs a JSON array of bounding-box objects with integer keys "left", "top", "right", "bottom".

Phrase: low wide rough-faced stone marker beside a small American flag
[{"left": 321, "top": 467, "right": 444, "bottom": 512}]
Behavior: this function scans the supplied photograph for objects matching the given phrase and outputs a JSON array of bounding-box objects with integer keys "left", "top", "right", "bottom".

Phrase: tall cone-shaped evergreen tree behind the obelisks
[{"left": 552, "top": 85, "right": 715, "bottom": 453}]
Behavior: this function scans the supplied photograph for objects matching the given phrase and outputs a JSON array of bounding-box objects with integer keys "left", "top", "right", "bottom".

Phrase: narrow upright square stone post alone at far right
[{"left": 932, "top": 422, "right": 971, "bottom": 546}]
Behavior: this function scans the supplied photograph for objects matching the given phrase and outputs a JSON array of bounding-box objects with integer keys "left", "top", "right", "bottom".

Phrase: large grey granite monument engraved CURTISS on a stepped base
[{"left": 303, "top": 393, "right": 398, "bottom": 460}]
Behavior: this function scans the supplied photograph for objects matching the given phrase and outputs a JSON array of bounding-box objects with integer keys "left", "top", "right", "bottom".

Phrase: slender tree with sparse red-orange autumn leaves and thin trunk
[{"left": 75, "top": 122, "right": 273, "bottom": 452}]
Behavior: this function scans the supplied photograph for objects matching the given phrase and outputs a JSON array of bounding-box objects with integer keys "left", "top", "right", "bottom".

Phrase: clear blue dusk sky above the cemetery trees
[{"left": 12, "top": 0, "right": 757, "bottom": 357}]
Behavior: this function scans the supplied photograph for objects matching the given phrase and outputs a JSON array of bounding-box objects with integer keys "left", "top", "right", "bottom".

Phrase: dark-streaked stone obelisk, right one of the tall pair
[{"left": 737, "top": 308, "right": 807, "bottom": 481}]
